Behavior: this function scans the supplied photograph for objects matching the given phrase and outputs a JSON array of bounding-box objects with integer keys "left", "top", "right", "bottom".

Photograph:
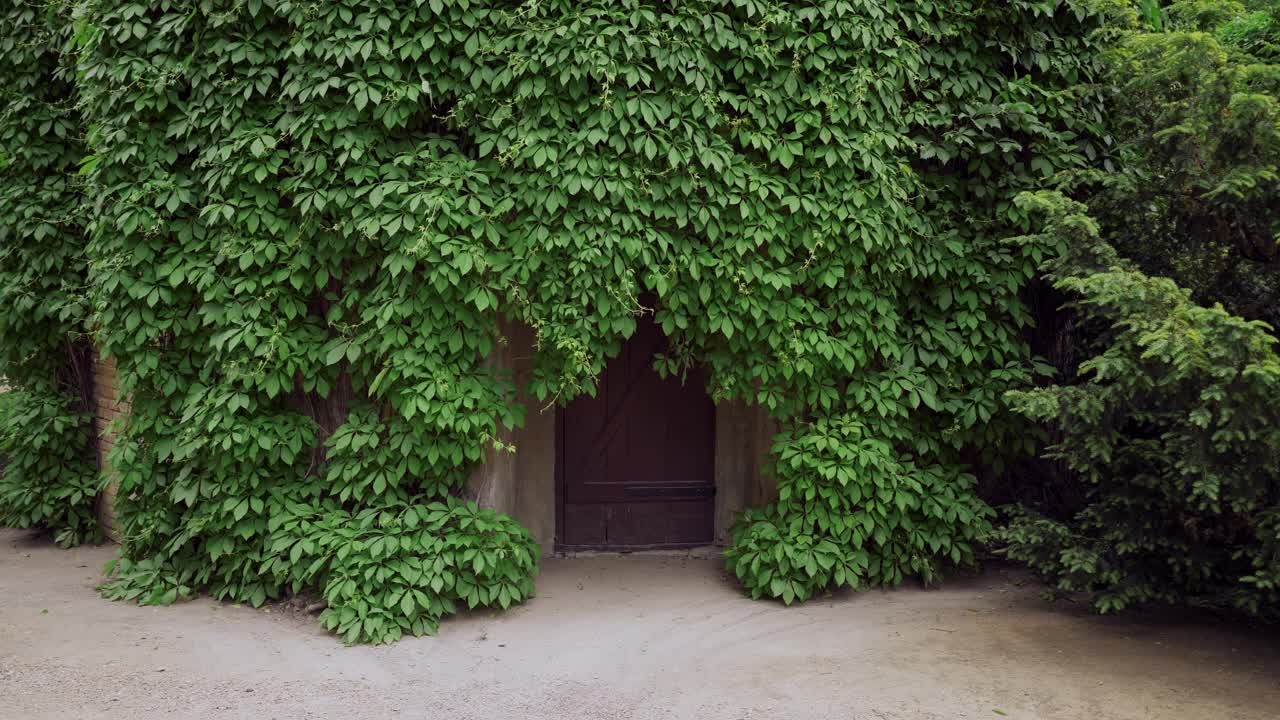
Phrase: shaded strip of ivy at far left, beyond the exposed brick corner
[{"left": 0, "top": 1, "right": 101, "bottom": 546}]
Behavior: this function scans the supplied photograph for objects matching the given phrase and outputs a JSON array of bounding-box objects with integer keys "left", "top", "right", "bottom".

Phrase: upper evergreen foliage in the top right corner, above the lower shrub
[{"left": 1083, "top": 0, "right": 1280, "bottom": 327}]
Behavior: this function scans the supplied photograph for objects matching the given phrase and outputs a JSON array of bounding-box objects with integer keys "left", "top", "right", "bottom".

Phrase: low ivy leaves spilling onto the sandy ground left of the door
[{"left": 102, "top": 498, "right": 539, "bottom": 643}]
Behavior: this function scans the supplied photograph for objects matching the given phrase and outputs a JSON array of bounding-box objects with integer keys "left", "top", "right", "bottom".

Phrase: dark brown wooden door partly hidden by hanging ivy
[{"left": 557, "top": 312, "right": 716, "bottom": 550}]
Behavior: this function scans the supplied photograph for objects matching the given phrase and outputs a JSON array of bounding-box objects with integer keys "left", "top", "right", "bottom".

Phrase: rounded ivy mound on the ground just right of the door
[{"left": 726, "top": 415, "right": 993, "bottom": 605}]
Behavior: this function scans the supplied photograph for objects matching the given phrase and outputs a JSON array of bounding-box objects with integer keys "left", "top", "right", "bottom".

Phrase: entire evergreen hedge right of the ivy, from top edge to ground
[{"left": 1002, "top": 0, "right": 1280, "bottom": 620}]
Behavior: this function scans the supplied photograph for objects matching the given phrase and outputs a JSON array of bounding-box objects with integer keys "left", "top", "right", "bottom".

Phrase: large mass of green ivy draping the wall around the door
[{"left": 0, "top": 0, "right": 1097, "bottom": 641}]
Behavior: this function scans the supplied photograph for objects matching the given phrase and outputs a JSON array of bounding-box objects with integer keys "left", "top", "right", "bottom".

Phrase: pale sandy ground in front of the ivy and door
[{"left": 0, "top": 530, "right": 1280, "bottom": 720}]
